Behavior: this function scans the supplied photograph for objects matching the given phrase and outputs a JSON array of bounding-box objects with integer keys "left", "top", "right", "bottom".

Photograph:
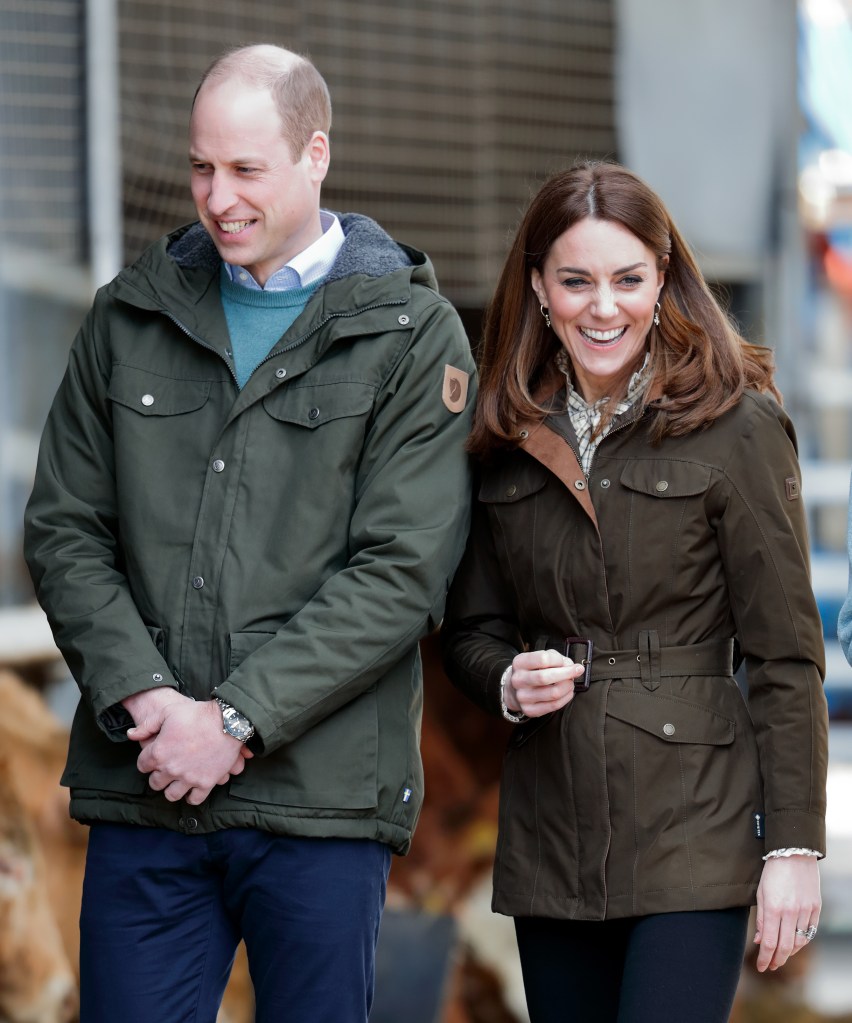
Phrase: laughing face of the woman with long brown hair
[{"left": 532, "top": 217, "right": 664, "bottom": 402}]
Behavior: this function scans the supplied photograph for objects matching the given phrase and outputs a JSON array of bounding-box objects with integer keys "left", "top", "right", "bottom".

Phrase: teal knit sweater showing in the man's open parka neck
[{"left": 220, "top": 267, "right": 322, "bottom": 388}]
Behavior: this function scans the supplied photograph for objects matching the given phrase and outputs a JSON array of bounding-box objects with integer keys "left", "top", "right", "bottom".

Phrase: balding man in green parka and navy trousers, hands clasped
[{"left": 26, "top": 46, "right": 473, "bottom": 1023}]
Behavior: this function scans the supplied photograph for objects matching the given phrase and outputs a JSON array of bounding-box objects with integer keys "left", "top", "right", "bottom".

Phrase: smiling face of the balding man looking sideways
[{"left": 189, "top": 78, "right": 328, "bottom": 285}]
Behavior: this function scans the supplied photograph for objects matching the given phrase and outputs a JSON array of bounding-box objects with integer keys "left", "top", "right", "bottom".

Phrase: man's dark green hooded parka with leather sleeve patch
[{"left": 26, "top": 215, "right": 474, "bottom": 852}]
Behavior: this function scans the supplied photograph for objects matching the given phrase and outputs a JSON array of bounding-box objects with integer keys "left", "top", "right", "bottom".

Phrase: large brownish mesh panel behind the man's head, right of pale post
[{"left": 121, "top": 0, "right": 615, "bottom": 307}]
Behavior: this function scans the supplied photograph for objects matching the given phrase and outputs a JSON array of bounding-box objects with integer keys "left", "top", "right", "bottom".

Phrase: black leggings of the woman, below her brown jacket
[{"left": 514, "top": 908, "right": 749, "bottom": 1023}]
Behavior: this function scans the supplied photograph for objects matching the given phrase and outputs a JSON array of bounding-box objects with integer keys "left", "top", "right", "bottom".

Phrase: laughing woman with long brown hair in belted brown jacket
[{"left": 442, "top": 164, "right": 826, "bottom": 1023}]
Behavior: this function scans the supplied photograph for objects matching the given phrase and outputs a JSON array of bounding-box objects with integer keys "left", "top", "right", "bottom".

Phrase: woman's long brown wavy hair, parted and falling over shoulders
[{"left": 467, "top": 162, "right": 780, "bottom": 455}]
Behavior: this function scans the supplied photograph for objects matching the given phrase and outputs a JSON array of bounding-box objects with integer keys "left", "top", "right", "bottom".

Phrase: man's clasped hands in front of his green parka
[{"left": 122, "top": 686, "right": 254, "bottom": 806}]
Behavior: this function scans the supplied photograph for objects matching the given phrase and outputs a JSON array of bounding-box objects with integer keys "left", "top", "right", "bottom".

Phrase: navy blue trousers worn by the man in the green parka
[{"left": 80, "top": 825, "right": 391, "bottom": 1023}]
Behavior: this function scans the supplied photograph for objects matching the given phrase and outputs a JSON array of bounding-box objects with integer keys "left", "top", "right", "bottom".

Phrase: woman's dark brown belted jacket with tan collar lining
[{"left": 443, "top": 392, "right": 826, "bottom": 920}]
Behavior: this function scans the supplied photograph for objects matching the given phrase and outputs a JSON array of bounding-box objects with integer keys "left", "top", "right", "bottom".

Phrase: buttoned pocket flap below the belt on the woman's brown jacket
[{"left": 607, "top": 686, "right": 736, "bottom": 746}]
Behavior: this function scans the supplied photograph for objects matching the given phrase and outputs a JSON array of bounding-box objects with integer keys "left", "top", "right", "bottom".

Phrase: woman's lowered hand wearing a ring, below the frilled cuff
[{"left": 755, "top": 856, "right": 822, "bottom": 973}]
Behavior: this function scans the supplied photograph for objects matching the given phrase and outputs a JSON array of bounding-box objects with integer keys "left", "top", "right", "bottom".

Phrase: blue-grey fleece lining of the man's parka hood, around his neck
[{"left": 168, "top": 213, "right": 412, "bottom": 283}]
